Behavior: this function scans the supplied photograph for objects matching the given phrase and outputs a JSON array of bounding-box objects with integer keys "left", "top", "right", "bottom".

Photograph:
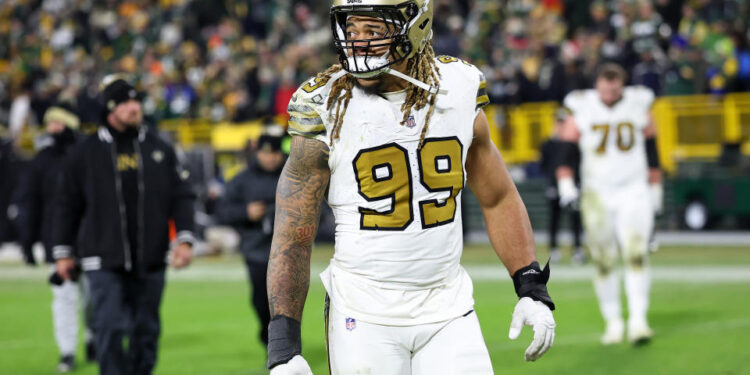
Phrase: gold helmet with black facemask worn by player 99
[{"left": 331, "top": 1, "right": 421, "bottom": 78}]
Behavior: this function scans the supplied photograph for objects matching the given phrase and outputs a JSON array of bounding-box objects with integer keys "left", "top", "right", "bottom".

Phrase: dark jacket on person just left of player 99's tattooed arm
[{"left": 218, "top": 162, "right": 281, "bottom": 262}]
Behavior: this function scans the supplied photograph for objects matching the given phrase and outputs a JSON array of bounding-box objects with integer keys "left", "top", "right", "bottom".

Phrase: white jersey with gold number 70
[{"left": 564, "top": 86, "right": 654, "bottom": 190}]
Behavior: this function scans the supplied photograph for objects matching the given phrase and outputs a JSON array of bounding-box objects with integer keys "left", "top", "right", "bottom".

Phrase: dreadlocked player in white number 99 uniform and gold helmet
[{"left": 268, "top": 0, "right": 555, "bottom": 375}]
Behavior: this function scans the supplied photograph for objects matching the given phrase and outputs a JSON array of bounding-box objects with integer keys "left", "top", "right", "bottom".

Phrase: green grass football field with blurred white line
[{"left": 0, "top": 246, "right": 750, "bottom": 375}]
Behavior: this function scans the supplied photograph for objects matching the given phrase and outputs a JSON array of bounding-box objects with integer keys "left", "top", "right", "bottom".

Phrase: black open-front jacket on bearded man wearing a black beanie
[{"left": 53, "top": 127, "right": 194, "bottom": 271}]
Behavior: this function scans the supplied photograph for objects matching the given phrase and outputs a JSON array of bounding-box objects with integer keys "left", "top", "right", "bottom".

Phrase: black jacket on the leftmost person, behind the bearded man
[{"left": 16, "top": 135, "right": 75, "bottom": 263}]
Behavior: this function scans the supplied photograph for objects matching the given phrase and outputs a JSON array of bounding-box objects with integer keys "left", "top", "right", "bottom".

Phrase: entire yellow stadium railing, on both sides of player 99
[{"left": 154, "top": 93, "right": 750, "bottom": 171}]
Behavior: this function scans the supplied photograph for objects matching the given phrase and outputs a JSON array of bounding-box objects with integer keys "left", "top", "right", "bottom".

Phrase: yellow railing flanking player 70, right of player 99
[{"left": 486, "top": 93, "right": 750, "bottom": 172}]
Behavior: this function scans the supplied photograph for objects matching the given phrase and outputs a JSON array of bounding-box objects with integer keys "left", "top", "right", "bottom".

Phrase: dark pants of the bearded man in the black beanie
[{"left": 86, "top": 269, "right": 164, "bottom": 375}]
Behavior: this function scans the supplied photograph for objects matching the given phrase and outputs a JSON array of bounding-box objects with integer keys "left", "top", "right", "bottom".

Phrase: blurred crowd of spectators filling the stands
[{"left": 0, "top": 0, "right": 750, "bottom": 135}]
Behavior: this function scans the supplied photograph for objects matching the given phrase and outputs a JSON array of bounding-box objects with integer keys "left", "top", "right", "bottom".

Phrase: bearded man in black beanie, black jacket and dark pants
[{"left": 53, "top": 75, "right": 194, "bottom": 375}]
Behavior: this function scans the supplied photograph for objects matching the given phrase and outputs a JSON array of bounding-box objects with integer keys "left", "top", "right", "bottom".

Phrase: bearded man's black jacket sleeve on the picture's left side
[{"left": 52, "top": 152, "right": 86, "bottom": 259}]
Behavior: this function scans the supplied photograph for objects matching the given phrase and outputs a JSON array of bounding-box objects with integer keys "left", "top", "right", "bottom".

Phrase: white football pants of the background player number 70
[{"left": 581, "top": 182, "right": 654, "bottom": 321}]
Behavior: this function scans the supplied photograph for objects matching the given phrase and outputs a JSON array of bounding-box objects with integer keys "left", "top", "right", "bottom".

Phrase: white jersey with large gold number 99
[{"left": 288, "top": 56, "right": 488, "bottom": 325}]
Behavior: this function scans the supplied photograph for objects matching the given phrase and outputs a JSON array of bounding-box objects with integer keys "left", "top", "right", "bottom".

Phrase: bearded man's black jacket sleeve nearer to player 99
[{"left": 168, "top": 151, "right": 195, "bottom": 244}]
